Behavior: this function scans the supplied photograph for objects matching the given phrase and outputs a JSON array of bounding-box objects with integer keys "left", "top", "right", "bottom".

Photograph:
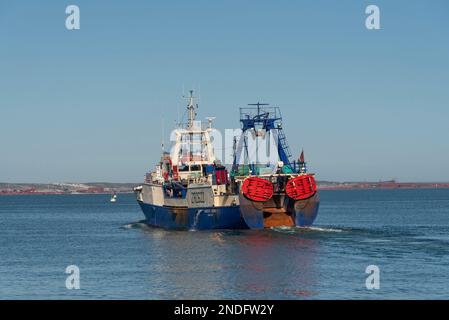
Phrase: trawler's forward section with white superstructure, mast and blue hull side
[{"left": 134, "top": 91, "right": 246, "bottom": 230}]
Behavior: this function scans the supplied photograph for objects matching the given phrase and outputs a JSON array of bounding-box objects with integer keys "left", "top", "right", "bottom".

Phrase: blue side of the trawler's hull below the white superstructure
[{"left": 139, "top": 201, "right": 248, "bottom": 230}]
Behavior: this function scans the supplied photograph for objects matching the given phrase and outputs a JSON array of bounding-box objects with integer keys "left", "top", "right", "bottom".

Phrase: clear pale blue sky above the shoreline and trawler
[{"left": 0, "top": 0, "right": 449, "bottom": 182}]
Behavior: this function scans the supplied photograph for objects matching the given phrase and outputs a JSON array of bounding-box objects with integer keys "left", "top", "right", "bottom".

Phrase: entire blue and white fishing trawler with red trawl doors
[{"left": 134, "top": 91, "right": 319, "bottom": 230}]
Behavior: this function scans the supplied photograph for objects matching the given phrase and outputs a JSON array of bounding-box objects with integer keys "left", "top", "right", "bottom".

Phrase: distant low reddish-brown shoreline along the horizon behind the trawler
[{"left": 0, "top": 180, "right": 449, "bottom": 196}]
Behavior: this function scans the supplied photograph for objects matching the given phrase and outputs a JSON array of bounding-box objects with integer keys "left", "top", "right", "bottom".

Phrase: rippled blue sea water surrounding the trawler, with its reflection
[{"left": 0, "top": 189, "right": 449, "bottom": 299}]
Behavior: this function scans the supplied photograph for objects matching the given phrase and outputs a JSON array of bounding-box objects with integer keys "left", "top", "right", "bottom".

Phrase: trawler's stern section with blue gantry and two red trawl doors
[{"left": 231, "top": 103, "right": 319, "bottom": 229}]
